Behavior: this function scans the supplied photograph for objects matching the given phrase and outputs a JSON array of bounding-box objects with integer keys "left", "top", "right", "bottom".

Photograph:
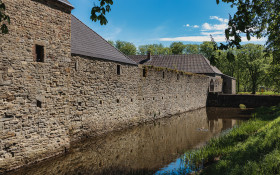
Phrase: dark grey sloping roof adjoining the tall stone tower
[{"left": 71, "top": 15, "right": 137, "bottom": 65}]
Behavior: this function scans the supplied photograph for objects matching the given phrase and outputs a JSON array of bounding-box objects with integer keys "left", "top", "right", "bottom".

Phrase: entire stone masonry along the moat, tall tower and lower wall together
[{"left": 0, "top": 0, "right": 209, "bottom": 173}]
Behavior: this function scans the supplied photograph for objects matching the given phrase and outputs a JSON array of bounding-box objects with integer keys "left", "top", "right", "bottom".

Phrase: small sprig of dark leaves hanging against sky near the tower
[{"left": 90, "top": 0, "right": 113, "bottom": 25}]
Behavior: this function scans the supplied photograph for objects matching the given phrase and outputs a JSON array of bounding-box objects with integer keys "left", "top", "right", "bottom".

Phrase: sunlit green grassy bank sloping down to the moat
[{"left": 182, "top": 106, "right": 280, "bottom": 175}]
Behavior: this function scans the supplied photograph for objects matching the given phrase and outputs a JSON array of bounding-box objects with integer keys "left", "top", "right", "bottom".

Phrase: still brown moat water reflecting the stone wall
[{"left": 8, "top": 108, "right": 251, "bottom": 175}]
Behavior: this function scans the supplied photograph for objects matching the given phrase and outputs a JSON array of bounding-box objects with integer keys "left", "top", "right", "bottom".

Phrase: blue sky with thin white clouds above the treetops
[{"left": 69, "top": 0, "right": 264, "bottom": 46}]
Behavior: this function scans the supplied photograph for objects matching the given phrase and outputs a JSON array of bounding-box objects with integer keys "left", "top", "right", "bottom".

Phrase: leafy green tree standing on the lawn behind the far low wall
[{"left": 214, "top": 44, "right": 272, "bottom": 94}]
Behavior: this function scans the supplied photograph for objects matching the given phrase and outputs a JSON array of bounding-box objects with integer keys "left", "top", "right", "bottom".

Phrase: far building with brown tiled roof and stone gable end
[{"left": 129, "top": 54, "right": 236, "bottom": 94}]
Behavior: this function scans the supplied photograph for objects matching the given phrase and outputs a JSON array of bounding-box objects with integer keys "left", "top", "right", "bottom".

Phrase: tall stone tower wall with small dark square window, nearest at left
[{"left": 0, "top": 0, "right": 71, "bottom": 174}]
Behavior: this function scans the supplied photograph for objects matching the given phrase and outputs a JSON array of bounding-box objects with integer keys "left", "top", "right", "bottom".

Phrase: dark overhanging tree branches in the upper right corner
[{"left": 216, "top": 0, "right": 280, "bottom": 63}]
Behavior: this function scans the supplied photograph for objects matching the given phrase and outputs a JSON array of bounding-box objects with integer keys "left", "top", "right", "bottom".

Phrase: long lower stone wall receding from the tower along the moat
[{"left": 67, "top": 55, "right": 208, "bottom": 141}]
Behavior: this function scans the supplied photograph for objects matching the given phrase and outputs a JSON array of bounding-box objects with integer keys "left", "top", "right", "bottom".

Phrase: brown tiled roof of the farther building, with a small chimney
[{"left": 129, "top": 54, "right": 223, "bottom": 74}]
